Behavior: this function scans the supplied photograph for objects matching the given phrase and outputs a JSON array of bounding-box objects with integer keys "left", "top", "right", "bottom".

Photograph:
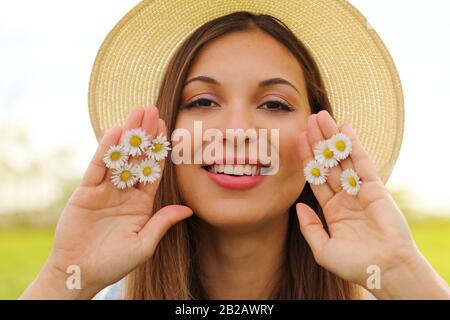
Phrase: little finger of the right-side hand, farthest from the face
[{"left": 341, "top": 123, "right": 381, "bottom": 182}]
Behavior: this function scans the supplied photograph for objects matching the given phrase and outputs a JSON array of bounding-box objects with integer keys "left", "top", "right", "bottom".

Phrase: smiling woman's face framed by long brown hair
[{"left": 174, "top": 31, "right": 310, "bottom": 231}]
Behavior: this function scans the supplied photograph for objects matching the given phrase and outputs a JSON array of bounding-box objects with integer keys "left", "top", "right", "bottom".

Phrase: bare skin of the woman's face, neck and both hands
[{"left": 21, "top": 32, "right": 450, "bottom": 299}]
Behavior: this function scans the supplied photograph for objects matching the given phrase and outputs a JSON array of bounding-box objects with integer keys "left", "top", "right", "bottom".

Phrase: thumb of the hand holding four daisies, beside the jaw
[{"left": 296, "top": 203, "right": 330, "bottom": 264}]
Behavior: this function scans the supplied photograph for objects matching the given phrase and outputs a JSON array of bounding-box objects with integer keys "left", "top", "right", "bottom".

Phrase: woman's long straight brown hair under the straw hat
[{"left": 126, "top": 11, "right": 357, "bottom": 299}]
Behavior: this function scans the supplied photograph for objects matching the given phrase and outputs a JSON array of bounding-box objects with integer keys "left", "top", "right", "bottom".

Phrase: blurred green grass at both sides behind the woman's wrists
[{"left": 0, "top": 219, "right": 450, "bottom": 299}]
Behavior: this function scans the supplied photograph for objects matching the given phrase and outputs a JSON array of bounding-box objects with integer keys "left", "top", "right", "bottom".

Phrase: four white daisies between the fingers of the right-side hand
[{"left": 304, "top": 133, "right": 362, "bottom": 195}]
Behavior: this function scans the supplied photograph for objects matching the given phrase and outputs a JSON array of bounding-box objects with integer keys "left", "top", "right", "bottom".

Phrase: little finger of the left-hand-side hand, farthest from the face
[{"left": 80, "top": 127, "right": 122, "bottom": 187}]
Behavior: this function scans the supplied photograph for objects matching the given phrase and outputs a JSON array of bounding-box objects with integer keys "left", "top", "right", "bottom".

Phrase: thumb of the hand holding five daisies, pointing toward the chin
[{"left": 139, "top": 205, "right": 192, "bottom": 257}]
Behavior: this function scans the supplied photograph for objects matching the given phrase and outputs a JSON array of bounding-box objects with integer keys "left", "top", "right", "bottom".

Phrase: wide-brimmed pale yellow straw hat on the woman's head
[{"left": 89, "top": 0, "right": 404, "bottom": 182}]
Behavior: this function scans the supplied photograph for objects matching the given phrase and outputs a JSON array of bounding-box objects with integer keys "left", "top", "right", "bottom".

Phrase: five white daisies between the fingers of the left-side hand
[{"left": 103, "top": 128, "right": 171, "bottom": 189}]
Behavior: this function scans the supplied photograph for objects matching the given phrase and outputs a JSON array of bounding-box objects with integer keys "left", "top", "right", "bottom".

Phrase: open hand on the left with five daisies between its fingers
[{"left": 21, "top": 107, "right": 192, "bottom": 299}]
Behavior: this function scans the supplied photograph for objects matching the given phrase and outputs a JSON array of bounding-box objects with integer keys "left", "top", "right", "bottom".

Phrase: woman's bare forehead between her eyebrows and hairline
[{"left": 185, "top": 31, "right": 303, "bottom": 85}]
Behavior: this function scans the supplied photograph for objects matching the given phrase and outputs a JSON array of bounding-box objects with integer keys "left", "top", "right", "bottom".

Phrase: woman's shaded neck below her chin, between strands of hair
[{"left": 198, "top": 213, "right": 289, "bottom": 300}]
